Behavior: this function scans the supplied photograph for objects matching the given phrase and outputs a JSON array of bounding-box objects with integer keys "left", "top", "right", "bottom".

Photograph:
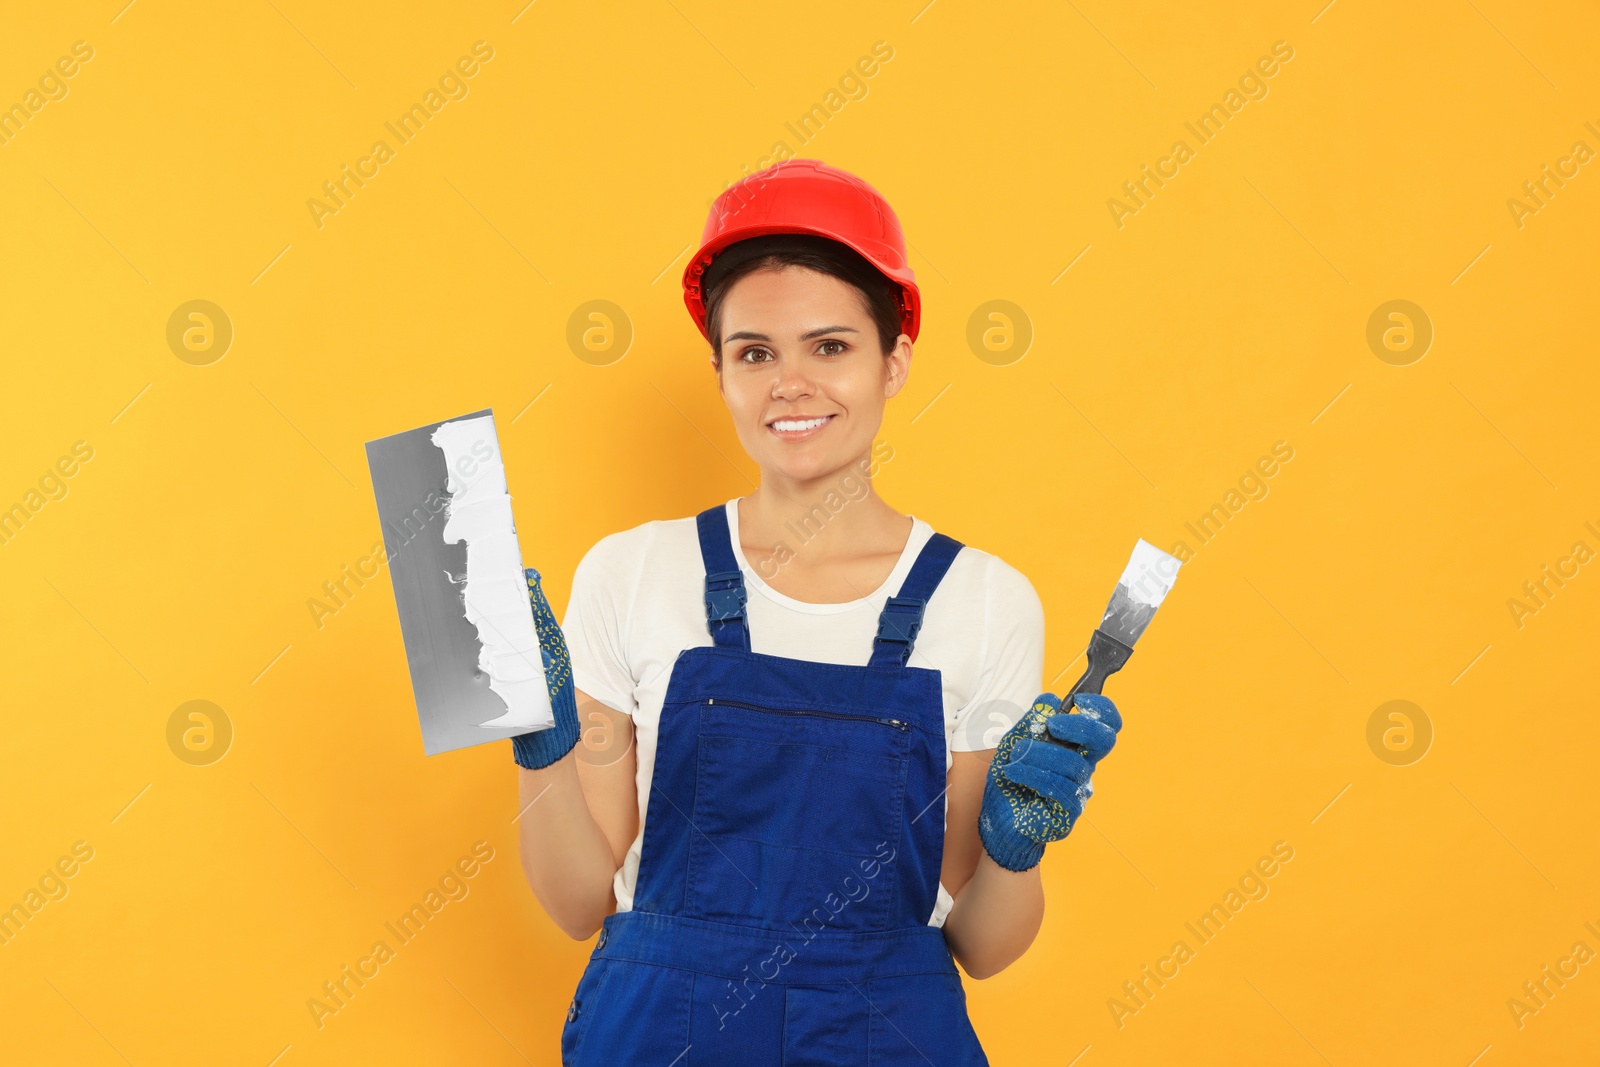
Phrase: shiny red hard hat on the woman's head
[{"left": 683, "top": 160, "right": 922, "bottom": 341}]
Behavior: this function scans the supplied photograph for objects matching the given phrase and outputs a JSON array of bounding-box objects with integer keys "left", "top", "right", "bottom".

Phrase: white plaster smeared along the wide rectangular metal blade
[{"left": 429, "top": 414, "right": 555, "bottom": 729}]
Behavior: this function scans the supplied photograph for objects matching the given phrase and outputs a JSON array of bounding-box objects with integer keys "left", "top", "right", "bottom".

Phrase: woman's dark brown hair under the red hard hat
[{"left": 702, "top": 234, "right": 901, "bottom": 370}]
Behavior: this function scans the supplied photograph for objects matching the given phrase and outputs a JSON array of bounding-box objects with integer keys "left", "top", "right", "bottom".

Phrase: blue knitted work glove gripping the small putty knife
[{"left": 978, "top": 693, "right": 1122, "bottom": 870}]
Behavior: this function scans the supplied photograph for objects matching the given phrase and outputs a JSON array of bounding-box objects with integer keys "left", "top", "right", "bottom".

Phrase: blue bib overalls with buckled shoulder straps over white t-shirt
[{"left": 562, "top": 506, "right": 989, "bottom": 1067}]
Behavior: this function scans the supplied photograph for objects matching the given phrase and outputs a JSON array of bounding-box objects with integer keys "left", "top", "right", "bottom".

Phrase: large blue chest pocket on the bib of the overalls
[{"left": 685, "top": 701, "right": 910, "bottom": 936}]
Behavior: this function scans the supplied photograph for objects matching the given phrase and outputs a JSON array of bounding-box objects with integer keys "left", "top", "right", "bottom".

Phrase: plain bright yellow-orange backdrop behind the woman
[{"left": 0, "top": 0, "right": 1600, "bottom": 1067}]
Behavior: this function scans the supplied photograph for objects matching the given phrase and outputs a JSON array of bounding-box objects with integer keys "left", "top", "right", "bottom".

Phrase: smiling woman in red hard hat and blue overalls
[{"left": 514, "top": 160, "right": 1122, "bottom": 1067}]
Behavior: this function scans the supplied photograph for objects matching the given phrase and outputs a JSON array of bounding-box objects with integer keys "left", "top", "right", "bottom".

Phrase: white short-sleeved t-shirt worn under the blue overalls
[{"left": 562, "top": 498, "right": 1045, "bottom": 926}]
